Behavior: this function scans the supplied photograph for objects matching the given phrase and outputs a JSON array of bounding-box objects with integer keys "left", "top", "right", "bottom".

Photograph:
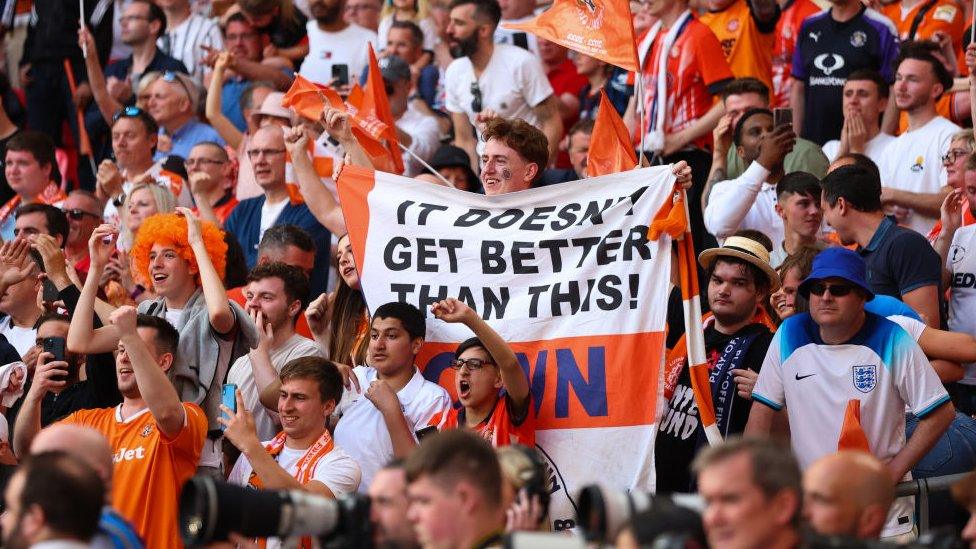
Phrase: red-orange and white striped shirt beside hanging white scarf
[{"left": 634, "top": 17, "right": 734, "bottom": 150}]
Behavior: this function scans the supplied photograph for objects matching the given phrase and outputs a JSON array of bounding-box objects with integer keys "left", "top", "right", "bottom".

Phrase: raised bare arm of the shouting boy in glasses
[{"left": 430, "top": 297, "right": 529, "bottom": 412}]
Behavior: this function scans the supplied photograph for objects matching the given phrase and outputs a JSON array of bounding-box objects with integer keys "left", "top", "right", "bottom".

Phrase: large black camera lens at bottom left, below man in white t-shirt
[{"left": 180, "top": 475, "right": 373, "bottom": 548}]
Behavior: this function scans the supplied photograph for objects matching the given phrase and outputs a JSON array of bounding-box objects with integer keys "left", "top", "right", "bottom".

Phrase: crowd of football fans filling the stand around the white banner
[{"left": 0, "top": 0, "right": 976, "bottom": 548}]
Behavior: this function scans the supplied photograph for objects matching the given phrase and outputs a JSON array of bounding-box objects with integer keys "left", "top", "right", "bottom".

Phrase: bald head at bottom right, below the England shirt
[{"left": 803, "top": 451, "right": 895, "bottom": 539}]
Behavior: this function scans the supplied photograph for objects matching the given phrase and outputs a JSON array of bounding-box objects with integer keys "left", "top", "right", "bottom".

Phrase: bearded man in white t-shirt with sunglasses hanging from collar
[{"left": 444, "top": 0, "right": 563, "bottom": 172}]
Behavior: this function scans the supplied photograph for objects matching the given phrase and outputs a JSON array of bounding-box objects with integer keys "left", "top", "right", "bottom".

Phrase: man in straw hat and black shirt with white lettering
[{"left": 654, "top": 232, "right": 780, "bottom": 493}]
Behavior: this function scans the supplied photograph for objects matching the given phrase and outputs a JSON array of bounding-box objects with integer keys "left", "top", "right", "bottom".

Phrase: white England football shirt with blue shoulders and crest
[{"left": 752, "top": 313, "right": 949, "bottom": 537}]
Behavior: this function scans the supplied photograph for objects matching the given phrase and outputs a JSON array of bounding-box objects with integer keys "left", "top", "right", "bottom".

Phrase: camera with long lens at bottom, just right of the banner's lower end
[{"left": 576, "top": 484, "right": 701, "bottom": 543}]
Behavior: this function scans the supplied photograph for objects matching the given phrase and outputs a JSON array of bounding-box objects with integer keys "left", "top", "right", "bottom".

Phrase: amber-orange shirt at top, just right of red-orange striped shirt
[{"left": 701, "top": 0, "right": 776, "bottom": 89}]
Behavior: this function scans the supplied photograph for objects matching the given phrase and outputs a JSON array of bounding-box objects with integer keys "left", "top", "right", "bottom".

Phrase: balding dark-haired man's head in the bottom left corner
[{"left": 2, "top": 452, "right": 105, "bottom": 549}]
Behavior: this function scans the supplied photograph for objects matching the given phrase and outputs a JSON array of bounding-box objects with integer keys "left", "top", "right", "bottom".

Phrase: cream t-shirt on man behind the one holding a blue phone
[{"left": 227, "top": 334, "right": 324, "bottom": 440}]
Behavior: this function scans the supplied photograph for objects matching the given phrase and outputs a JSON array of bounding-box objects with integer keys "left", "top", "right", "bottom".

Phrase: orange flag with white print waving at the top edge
[{"left": 502, "top": 0, "right": 638, "bottom": 72}]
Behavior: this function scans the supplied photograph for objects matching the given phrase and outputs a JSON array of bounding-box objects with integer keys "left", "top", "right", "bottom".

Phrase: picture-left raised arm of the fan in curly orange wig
[{"left": 67, "top": 224, "right": 119, "bottom": 354}]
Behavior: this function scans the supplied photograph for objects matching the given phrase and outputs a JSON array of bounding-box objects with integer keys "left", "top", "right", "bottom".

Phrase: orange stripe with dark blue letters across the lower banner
[{"left": 417, "top": 332, "right": 664, "bottom": 429}]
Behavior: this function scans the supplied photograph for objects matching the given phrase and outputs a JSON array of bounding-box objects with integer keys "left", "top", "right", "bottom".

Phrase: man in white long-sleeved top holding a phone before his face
[{"left": 704, "top": 109, "right": 796, "bottom": 244}]
